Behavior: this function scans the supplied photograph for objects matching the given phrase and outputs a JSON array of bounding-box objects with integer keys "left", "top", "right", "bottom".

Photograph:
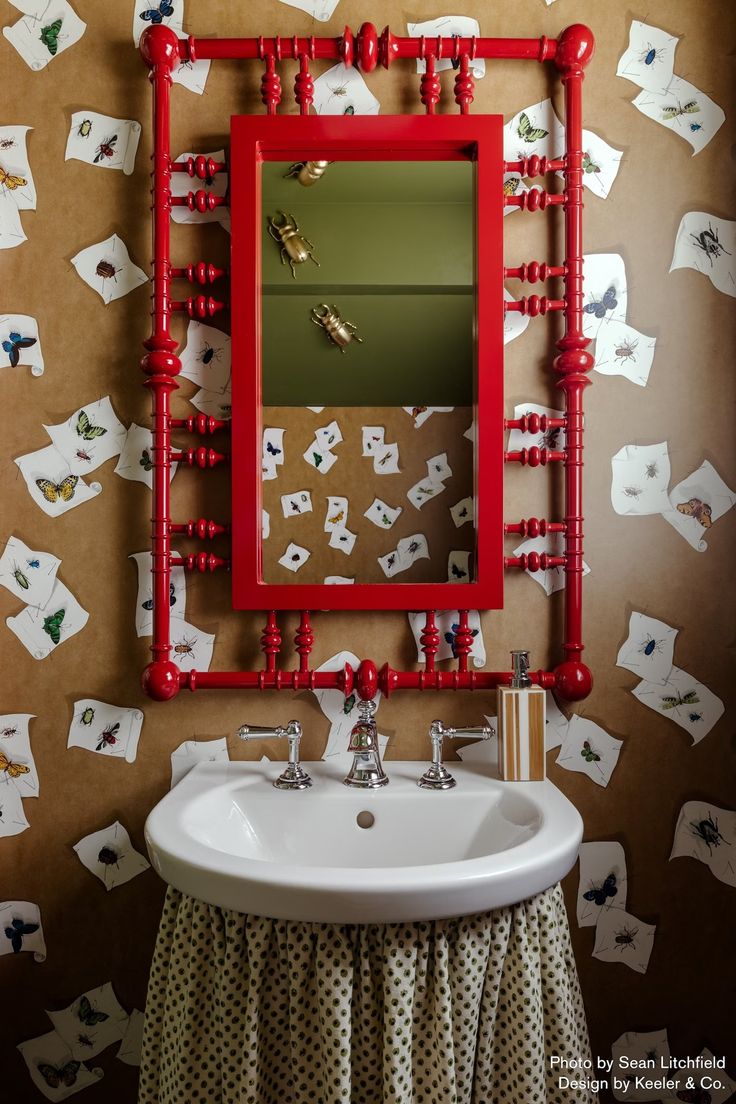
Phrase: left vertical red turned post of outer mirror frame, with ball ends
[{"left": 140, "top": 26, "right": 181, "bottom": 701}]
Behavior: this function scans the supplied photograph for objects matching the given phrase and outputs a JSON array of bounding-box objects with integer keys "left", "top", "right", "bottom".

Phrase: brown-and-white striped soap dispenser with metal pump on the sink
[{"left": 498, "top": 651, "right": 546, "bottom": 782}]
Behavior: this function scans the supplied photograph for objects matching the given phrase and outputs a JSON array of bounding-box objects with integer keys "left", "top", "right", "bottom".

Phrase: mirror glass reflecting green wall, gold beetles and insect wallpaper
[{"left": 262, "top": 161, "right": 476, "bottom": 584}]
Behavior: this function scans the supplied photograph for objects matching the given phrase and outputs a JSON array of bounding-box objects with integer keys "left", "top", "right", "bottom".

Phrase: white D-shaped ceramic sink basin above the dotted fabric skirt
[{"left": 146, "top": 756, "right": 583, "bottom": 923}]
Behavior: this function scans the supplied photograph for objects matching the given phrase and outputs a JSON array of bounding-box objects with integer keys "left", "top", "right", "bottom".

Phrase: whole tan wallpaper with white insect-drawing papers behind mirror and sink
[{"left": 0, "top": 0, "right": 736, "bottom": 1104}]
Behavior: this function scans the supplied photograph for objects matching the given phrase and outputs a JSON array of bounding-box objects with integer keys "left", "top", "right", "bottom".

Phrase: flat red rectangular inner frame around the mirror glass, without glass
[{"left": 230, "top": 115, "right": 504, "bottom": 609}]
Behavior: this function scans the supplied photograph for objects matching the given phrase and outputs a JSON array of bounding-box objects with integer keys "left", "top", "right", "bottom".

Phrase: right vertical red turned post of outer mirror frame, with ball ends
[{"left": 554, "top": 24, "right": 594, "bottom": 701}]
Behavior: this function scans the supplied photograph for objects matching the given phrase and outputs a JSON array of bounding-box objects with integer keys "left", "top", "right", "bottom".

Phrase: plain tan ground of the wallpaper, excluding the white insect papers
[{"left": 0, "top": 0, "right": 736, "bottom": 1104}]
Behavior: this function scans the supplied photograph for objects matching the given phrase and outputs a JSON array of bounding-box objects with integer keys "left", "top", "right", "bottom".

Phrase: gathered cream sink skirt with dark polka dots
[{"left": 138, "top": 885, "right": 597, "bottom": 1104}]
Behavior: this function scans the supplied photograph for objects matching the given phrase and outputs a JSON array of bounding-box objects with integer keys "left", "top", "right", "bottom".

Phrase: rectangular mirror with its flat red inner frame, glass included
[{"left": 231, "top": 116, "right": 503, "bottom": 609}]
